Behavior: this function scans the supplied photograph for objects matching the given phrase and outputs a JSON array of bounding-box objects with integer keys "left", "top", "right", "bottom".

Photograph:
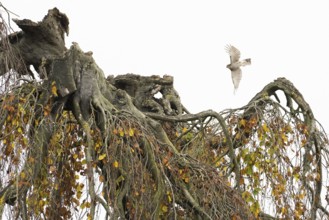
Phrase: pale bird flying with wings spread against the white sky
[{"left": 225, "top": 45, "right": 251, "bottom": 94}]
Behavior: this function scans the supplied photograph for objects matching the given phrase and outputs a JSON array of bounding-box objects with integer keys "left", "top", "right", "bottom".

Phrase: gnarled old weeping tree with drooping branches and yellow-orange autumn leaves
[{"left": 0, "top": 6, "right": 329, "bottom": 219}]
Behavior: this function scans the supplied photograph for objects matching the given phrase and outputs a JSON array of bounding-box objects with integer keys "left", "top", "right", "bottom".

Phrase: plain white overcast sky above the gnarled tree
[{"left": 0, "top": 0, "right": 329, "bottom": 132}]
